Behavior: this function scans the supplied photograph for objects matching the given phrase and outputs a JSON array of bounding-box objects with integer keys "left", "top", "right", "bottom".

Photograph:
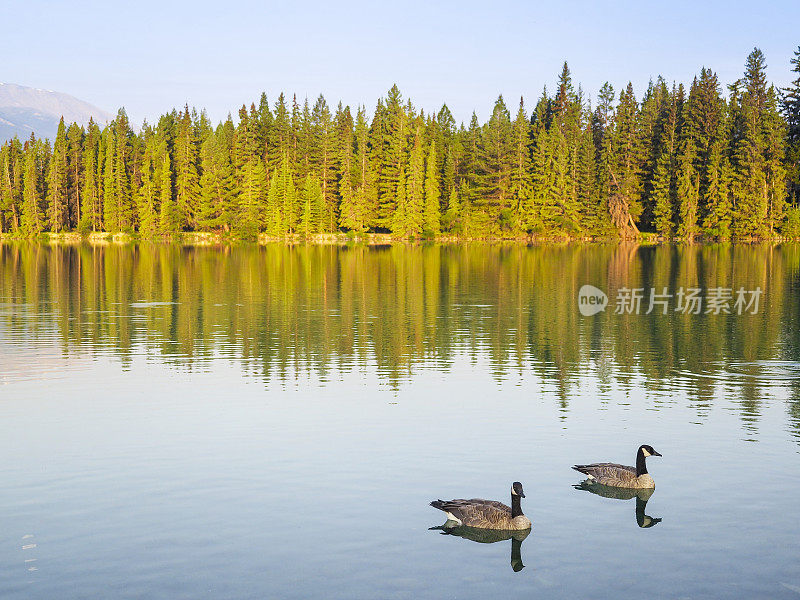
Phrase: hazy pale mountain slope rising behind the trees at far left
[{"left": 0, "top": 83, "right": 114, "bottom": 142}]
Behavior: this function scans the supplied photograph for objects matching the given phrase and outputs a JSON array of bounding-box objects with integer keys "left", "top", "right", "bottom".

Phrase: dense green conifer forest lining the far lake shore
[{"left": 0, "top": 47, "right": 800, "bottom": 241}]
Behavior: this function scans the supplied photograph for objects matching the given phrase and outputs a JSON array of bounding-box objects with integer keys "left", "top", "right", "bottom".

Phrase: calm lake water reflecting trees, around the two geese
[{"left": 0, "top": 244, "right": 800, "bottom": 599}]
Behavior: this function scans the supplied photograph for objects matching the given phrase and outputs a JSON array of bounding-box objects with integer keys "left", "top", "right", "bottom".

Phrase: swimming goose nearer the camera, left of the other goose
[{"left": 431, "top": 481, "right": 531, "bottom": 531}]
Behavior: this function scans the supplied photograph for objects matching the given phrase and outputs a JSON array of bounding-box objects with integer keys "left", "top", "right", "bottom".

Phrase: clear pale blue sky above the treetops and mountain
[{"left": 6, "top": 0, "right": 800, "bottom": 123}]
